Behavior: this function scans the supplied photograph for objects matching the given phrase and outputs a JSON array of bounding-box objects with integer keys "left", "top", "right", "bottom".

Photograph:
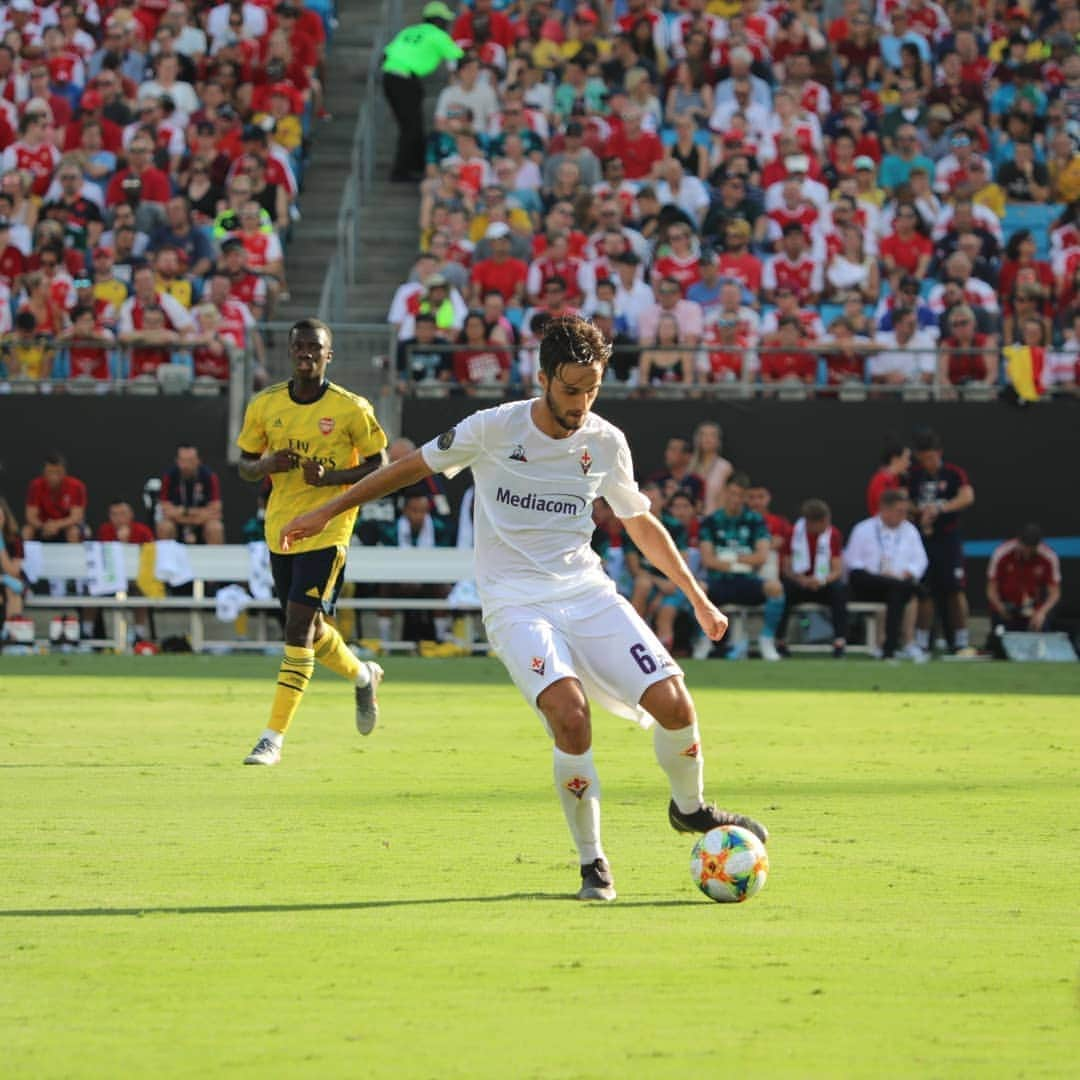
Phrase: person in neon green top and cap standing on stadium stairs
[{"left": 382, "top": 0, "right": 464, "bottom": 181}]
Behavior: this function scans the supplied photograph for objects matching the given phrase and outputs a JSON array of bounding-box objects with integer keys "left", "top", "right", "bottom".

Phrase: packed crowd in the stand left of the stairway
[{"left": 0, "top": 0, "right": 332, "bottom": 391}]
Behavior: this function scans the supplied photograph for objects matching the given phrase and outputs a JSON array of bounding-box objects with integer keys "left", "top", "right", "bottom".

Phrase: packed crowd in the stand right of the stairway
[{"left": 389, "top": 0, "right": 1080, "bottom": 399}]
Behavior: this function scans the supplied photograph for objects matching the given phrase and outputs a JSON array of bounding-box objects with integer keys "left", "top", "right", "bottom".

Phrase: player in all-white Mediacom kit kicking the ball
[{"left": 282, "top": 316, "right": 768, "bottom": 900}]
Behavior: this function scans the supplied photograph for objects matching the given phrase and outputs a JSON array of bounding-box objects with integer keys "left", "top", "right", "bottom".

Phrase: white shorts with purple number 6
[{"left": 484, "top": 591, "right": 683, "bottom": 733}]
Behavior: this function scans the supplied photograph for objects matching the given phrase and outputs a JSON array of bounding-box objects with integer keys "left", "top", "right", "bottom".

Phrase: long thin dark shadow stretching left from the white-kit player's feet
[{"left": 0, "top": 892, "right": 701, "bottom": 919}]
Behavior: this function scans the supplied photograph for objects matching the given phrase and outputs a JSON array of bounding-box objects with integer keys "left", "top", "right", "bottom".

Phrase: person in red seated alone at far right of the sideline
[{"left": 986, "top": 524, "right": 1062, "bottom": 631}]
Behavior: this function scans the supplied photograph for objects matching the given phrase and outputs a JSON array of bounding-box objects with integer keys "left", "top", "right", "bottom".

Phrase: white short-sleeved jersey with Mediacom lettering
[{"left": 420, "top": 401, "right": 649, "bottom": 616}]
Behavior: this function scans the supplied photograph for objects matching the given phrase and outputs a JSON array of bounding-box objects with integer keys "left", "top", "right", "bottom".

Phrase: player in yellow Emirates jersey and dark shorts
[{"left": 237, "top": 319, "right": 387, "bottom": 765}]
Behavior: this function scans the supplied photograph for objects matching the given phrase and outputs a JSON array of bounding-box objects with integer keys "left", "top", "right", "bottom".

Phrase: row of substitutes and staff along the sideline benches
[{"left": 0, "top": 422, "right": 1062, "bottom": 662}]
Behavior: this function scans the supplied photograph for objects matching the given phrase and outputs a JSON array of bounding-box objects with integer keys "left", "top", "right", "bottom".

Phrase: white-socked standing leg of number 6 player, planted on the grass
[{"left": 537, "top": 677, "right": 616, "bottom": 900}]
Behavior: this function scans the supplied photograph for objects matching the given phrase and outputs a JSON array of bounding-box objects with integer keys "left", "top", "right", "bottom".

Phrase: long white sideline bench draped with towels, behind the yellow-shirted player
[{"left": 26, "top": 544, "right": 480, "bottom": 652}]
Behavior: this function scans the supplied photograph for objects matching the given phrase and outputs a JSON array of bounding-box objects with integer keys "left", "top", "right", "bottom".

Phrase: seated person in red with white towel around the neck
[{"left": 777, "top": 499, "right": 848, "bottom": 660}]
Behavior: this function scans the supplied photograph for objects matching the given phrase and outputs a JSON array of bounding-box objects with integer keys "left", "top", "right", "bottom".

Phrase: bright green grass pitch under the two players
[{"left": 0, "top": 657, "right": 1080, "bottom": 1080}]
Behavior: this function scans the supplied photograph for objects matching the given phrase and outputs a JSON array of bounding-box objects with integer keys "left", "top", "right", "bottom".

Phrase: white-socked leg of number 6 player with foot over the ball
[{"left": 640, "top": 675, "right": 769, "bottom": 843}]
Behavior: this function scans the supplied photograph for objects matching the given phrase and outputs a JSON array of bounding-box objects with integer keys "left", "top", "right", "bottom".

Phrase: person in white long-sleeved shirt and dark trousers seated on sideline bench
[{"left": 843, "top": 488, "right": 928, "bottom": 663}]
